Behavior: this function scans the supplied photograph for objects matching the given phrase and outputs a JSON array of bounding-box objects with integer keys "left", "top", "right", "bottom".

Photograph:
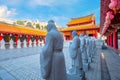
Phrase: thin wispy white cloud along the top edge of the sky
[{"left": 29, "top": 0, "right": 79, "bottom": 7}]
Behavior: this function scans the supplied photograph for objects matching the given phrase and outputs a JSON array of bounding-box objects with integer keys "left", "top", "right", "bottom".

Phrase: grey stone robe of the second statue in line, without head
[{"left": 69, "top": 36, "right": 82, "bottom": 70}]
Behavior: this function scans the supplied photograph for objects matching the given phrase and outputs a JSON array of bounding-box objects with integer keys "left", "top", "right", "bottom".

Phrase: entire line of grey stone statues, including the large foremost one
[{"left": 40, "top": 20, "right": 95, "bottom": 80}]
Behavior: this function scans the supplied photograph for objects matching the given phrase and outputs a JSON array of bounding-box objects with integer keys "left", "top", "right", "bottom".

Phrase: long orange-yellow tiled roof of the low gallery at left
[{"left": 0, "top": 23, "right": 47, "bottom": 36}]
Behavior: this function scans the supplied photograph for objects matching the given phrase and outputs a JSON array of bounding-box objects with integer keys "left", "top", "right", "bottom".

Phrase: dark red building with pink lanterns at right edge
[{"left": 100, "top": 0, "right": 120, "bottom": 49}]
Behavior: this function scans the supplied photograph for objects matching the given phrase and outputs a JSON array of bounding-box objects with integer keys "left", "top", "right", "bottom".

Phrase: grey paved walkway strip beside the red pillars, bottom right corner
[{"left": 102, "top": 48, "right": 120, "bottom": 80}]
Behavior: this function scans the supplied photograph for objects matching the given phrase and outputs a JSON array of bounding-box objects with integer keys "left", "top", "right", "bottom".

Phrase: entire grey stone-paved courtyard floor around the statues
[{"left": 0, "top": 46, "right": 120, "bottom": 80}]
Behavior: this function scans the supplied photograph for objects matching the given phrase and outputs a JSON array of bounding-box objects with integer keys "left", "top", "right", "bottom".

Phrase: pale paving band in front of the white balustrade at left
[{"left": 0, "top": 47, "right": 41, "bottom": 62}]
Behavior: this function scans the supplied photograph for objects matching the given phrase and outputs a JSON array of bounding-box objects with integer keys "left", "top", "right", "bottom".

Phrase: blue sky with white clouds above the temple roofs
[{"left": 0, "top": 0, "right": 100, "bottom": 27}]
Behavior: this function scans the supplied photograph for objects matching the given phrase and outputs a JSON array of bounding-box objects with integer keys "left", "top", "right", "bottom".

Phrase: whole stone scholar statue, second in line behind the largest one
[{"left": 69, "top": 31, "right": 85, "bottom": 80}]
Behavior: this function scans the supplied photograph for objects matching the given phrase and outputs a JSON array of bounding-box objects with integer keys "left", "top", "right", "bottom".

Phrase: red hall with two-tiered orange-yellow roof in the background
[{"left": 60, "top": 14, "right": 99, "bottom": 40}]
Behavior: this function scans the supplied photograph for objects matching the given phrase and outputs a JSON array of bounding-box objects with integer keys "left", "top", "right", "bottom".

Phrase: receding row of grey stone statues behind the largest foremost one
[{"left": 68, "top": 31, "right": 96, "bottom": 77}]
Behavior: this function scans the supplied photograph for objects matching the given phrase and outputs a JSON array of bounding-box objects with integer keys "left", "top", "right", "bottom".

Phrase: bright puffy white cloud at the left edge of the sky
[{"left": 0, "top": 5, "right": 17, "bottom": 18}]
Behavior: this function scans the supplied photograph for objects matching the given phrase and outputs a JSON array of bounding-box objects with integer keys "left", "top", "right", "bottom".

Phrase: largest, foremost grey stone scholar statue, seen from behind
[{"left": 40, "top": 20, "right": 67, "bottom": 80}]
